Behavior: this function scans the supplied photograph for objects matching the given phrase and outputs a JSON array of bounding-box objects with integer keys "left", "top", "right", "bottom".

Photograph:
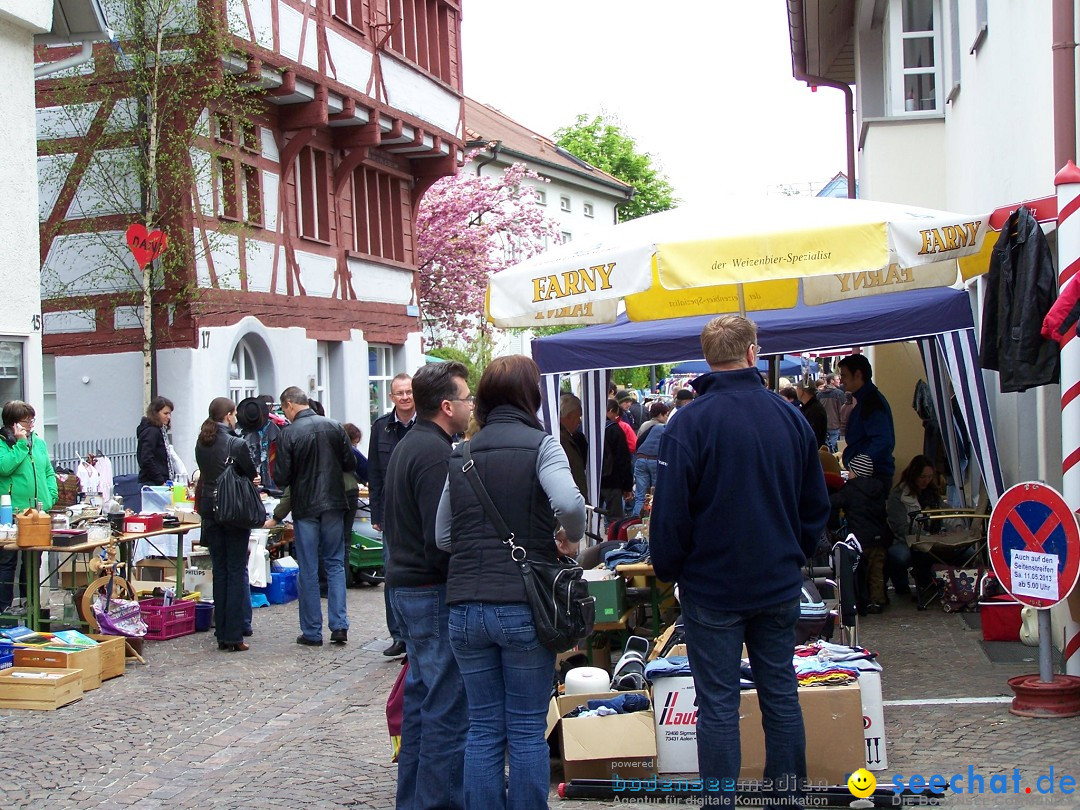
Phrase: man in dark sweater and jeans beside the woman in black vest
[{"left": 382, "top": 363, "right": 472, "bottom": 808}]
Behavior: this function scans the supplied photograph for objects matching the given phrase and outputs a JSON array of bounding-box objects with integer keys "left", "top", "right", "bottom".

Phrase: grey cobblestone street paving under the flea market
[{"left": 0, "top": 588, "right": 1080, "bottom": 810}]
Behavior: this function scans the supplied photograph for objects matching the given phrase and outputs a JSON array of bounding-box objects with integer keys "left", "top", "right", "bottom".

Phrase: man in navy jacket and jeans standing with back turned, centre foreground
[{"left": 649, "top": 315, "right": 829, "bottom": 807}]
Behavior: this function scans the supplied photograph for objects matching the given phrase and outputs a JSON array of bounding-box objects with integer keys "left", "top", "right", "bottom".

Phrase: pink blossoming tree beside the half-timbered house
[{"left": 416, "top": 152, "right": 559, "bottom": 347}]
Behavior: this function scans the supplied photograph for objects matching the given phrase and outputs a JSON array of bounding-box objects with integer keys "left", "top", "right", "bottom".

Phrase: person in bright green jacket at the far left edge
[{"left": 0, "top": 400, "right": 56, "bottom": 612}]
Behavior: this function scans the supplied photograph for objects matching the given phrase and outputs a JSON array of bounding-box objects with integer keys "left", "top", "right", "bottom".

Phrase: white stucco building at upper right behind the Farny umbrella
[{"left": 789, "top": 0, "right": 1076, "bottom": 487}]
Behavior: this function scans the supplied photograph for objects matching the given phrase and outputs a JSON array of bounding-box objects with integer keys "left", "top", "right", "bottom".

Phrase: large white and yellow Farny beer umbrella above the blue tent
[{"left": 487, "top": 197, "right": 991, "bottom": 326}]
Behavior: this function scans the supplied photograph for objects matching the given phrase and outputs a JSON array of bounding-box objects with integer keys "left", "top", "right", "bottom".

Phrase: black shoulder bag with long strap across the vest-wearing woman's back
[{"left": 461, "top": 442, "right": 596, "bottom": 652}]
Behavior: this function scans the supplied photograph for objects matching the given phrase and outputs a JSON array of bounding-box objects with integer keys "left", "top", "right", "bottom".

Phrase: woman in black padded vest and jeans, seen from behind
[{"left": 435, "top": 355, "right": 585, "bottom": 810}]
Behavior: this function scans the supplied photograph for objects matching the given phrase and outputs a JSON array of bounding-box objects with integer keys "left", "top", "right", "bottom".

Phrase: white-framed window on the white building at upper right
[{"left": 885, "top": 0, "right": 944, "bottom": 116}]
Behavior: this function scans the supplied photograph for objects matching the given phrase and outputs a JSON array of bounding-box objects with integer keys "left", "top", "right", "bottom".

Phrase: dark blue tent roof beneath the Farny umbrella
[{"left": 532, "top": 287, "right": 974, "bottom": 373}]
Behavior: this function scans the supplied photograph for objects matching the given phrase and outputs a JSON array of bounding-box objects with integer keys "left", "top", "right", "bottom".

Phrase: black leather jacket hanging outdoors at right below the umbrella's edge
[{"left": 978, "top": 206, "right": 1059, "bottom": 393}]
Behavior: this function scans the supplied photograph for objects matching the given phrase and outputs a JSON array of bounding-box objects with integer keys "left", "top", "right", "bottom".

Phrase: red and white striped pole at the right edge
[{"left": 1054, "top": 160, "right": 1080, "bottom": 675}]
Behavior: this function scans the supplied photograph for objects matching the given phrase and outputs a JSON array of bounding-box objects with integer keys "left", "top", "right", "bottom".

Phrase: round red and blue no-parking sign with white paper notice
[{"left": 987, "top": 482, "right": 1080, "bottom": 608}]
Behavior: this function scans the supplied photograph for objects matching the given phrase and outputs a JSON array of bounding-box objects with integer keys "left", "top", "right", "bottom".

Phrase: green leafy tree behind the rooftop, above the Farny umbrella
[{"left": 555, "top": 113, "right": 678, "bottom": 221}]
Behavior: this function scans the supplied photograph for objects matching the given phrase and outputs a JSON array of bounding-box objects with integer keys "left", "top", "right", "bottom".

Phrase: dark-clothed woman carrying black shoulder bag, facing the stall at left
[{"left": 195, "top": 396, "right": 258, "bottom": 652}]
